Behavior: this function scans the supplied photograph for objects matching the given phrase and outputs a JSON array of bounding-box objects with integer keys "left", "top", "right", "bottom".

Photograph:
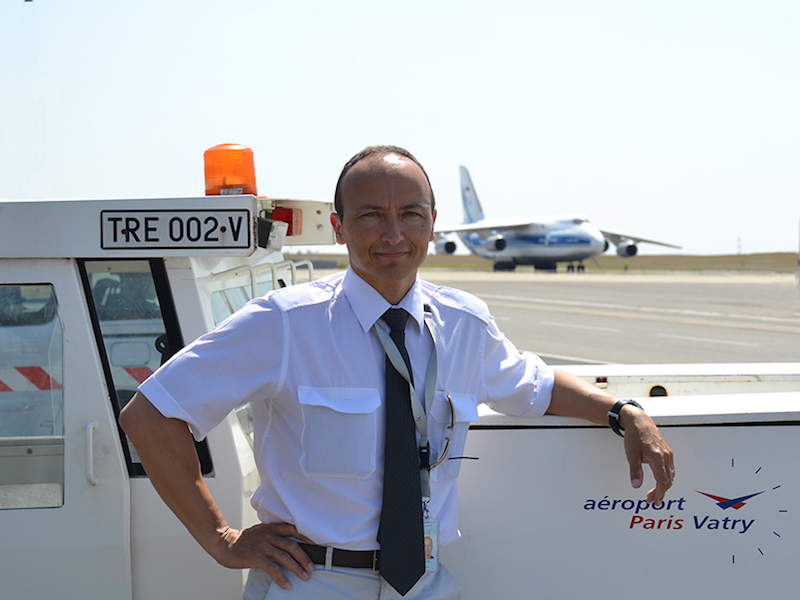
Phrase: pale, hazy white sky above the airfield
[{"left": 0, "top": 0, "right": 800, "bottom": 254}]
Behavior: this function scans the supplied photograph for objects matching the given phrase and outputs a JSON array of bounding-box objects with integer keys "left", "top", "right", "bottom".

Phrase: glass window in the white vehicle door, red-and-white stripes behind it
[{"left": 0, "top": 284, "right": 64, "bottom": 509}]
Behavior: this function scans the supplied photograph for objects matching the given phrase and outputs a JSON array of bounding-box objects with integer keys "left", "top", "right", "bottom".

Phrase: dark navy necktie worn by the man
[{"left": 378, "top": 308, "right": 425, "bottom": 596}]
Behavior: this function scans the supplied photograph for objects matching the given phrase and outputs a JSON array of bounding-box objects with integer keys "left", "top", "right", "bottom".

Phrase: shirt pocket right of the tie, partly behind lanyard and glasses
[{"left": 428, "top": 391, "right": 478, "bottom": 480}]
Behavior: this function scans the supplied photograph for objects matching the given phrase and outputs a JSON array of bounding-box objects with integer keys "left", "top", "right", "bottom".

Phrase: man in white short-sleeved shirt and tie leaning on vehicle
[{"left": 120, "top": 146, "right": 674, "bottom": 600}]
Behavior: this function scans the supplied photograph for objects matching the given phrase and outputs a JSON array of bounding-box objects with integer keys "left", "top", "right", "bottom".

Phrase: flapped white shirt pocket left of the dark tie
[{"left": 297, "top": 386, "right": 381, "bottom": 479}]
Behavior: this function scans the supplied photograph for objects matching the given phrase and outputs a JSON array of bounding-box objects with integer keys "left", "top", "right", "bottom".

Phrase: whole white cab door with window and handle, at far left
[{"left": 0, "top": 259, "right": 131, "bottom": 600}]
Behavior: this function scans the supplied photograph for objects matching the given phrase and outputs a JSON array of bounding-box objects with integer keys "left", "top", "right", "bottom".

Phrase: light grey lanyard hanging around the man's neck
[{"left": 373, "top": 304, "right": 444, "bottom": 498}]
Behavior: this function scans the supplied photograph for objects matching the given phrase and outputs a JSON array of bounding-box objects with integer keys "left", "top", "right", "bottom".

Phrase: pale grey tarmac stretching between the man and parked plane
[{"left": 420, "top": 269, "right": 800, "bottom": 364}]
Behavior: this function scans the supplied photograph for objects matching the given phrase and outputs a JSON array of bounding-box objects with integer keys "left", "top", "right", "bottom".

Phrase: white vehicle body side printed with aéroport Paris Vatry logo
[{"left": 441, "top": 392, "right": 800, "bottom": 600}]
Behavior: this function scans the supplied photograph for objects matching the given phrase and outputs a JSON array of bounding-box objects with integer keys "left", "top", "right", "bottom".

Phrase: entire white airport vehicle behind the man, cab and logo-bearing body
[{"left": 0, "top": 146, "right": 800, "bottom": 600}]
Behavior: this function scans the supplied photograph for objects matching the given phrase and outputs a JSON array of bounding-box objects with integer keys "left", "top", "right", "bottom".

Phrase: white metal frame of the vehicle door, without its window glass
[{"left": 0, "top": 260, "right": 132, "bottom": 599}]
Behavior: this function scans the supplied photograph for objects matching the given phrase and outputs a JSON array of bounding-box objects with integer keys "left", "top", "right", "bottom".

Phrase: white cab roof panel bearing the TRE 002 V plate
[{"left": 0, "top": 196, "right": 258, "bottom": 258}]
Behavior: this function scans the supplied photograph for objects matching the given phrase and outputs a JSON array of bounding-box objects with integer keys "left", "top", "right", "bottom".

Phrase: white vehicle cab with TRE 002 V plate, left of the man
[{"left": 0, "top": 148, "right": 334, "bottom": 600}]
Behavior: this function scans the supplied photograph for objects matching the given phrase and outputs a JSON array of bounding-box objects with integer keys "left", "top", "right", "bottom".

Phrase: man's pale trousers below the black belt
[{"left": 244, "top": 565, "right": 461, "bottom": 600}]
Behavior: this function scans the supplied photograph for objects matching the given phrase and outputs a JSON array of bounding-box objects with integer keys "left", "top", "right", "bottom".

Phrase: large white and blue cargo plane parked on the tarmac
[{"left": 434, "top": 166, "right": 680, "bottom": 271}]
